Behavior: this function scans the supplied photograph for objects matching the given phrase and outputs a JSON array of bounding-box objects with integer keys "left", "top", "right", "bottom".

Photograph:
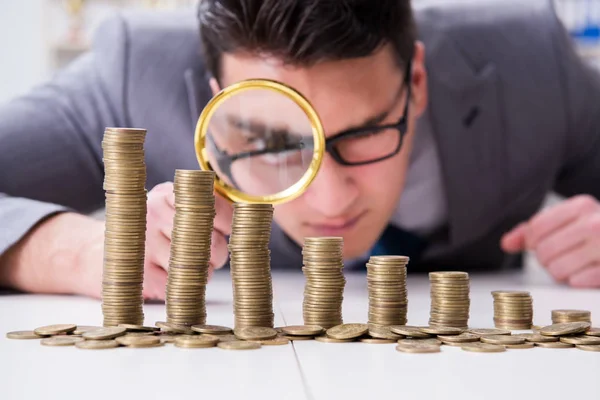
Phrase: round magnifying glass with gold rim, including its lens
[{"left": 194, "top": 79, "right": 325, "bottom": 205}]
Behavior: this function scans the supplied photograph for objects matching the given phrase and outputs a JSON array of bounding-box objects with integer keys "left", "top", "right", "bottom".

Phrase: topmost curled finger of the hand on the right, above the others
[{"left": 526, "top": 195, "right": 600, "bottom": 249}]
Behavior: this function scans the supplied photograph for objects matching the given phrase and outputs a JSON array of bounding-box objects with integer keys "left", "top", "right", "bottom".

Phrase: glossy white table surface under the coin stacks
[{"left": 0, "top": 271, "right": 600, "bottom": 400}]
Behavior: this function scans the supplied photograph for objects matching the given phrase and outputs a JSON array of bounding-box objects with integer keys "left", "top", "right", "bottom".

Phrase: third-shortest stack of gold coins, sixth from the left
[{"left": 429, "top": 271, "right": 471, "bottom": 329}]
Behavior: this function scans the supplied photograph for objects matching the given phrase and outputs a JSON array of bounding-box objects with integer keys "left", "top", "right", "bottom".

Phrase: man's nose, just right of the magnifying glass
[{"left": 304, "top": 154, "right": 359, "bottom": 218}]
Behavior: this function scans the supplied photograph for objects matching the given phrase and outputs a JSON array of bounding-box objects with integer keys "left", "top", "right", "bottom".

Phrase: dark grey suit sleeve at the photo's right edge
[{"left": 552, "top": 8, "right": 600, "bottom": 200}]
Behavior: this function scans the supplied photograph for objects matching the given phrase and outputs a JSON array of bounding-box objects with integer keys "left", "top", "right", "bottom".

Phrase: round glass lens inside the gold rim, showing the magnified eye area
[{"left": 205, "top": 88, "right": 315, "bottom": 196}]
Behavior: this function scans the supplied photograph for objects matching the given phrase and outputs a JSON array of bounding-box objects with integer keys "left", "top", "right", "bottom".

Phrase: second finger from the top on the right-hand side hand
[{"left": 533, "top": 217, "right": 593, "bottom": 265}]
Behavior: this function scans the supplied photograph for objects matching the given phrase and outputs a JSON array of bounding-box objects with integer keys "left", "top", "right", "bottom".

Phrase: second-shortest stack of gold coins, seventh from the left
[{"left": 492, "top": 290, "right": 533, "bottom": 330}]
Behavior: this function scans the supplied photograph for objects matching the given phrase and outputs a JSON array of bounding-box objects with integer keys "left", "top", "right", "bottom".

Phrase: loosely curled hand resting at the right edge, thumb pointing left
[{"left": 502, "top": 195, "right": 600, "bottom": 287}]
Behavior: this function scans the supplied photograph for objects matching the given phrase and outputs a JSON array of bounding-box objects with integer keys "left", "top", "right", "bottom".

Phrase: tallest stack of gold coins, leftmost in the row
[{"left": 102, "top": 128, "right": 147, "bottom": 326}]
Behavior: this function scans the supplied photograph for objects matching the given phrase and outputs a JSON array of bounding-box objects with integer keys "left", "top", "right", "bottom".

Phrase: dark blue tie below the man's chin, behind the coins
[{"left": 371, "top": 225, "right": 427, "bottom": 263}]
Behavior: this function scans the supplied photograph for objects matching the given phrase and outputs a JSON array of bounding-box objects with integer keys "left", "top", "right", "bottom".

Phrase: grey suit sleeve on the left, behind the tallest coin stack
[{"left": 0, "top": 18, "right": 128, "bottom": 255}]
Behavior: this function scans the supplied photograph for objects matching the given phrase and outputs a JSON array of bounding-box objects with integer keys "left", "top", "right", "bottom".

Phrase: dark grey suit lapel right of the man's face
[{"left": 427, "top": 39, "right": 508, "bottom": 248}]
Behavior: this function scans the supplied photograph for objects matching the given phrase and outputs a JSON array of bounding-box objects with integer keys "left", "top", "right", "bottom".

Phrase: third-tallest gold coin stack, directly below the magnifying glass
[{"left": 229, "top": 203, "right": 274, "bottom": 328}]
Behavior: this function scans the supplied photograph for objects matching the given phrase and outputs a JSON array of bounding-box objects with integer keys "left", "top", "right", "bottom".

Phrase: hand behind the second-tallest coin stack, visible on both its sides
[{"left": 144, "top": 182, "right": 233, "bottom": 300}]
